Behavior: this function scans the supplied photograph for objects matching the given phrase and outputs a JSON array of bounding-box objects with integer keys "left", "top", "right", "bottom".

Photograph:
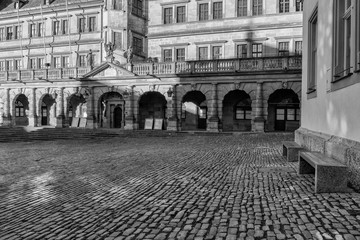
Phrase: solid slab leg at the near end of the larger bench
[{"left": 315, "top": 166, "right": 348, "bottom": 193}]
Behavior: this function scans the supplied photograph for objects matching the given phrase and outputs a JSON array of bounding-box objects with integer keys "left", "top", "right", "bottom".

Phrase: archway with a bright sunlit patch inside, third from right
[{"left": 181, "top": 91, "right": 207, "bottom": 130}]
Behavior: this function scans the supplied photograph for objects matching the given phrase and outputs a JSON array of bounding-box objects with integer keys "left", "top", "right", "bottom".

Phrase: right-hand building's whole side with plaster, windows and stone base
[{"left": 295, "top": 0, "right": 360, "bottom": 189}]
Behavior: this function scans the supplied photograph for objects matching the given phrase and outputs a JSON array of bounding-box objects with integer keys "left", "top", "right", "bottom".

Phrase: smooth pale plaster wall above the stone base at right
[{"left": 301, "top": 0, "right": 360, "bottom": 141}]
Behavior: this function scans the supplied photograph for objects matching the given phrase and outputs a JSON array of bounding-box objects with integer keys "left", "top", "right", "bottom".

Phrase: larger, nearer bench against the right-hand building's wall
[{"left": 299, "top": 152, "right": 349, "bottom": 193}]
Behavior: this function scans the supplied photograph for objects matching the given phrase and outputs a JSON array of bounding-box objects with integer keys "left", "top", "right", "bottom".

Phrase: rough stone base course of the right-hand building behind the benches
[{"left": 295, "top": 128, "right": 360, "bottom": 190}]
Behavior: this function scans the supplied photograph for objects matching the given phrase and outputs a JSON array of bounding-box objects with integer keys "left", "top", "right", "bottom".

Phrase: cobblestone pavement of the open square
[{"left": 0, "top": 134, "right": 360, "bottom": 240}]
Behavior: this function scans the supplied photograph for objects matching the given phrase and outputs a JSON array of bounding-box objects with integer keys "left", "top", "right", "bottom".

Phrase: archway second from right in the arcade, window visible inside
[{"left": 222, "top": 90, "right": 251, "bottom": 131}]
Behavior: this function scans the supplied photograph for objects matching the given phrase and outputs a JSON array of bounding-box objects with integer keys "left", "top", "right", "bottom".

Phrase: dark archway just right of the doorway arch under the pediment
[{"left": 139, "top": 92, "right": 167, "bottom": 129}]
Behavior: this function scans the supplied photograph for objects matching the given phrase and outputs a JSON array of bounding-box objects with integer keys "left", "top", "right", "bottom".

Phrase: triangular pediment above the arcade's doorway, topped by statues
[{"left": 83, "top": 62, "right": 135, "bottom": 79}]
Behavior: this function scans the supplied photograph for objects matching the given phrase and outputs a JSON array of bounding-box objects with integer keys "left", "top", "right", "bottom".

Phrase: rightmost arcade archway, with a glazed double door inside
[{"left": 268, "top": 89, "right": 300, "bottom": 131}]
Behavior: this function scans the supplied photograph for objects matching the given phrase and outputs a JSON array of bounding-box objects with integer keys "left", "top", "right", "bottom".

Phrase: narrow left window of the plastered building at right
[{"left": 307, "top": 9, "right": 318, "bottom": 93}]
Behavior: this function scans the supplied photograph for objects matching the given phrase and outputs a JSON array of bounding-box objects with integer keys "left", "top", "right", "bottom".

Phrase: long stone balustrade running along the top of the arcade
[{"left": 0, "top": 56, "right": 302, "bottom": 81}]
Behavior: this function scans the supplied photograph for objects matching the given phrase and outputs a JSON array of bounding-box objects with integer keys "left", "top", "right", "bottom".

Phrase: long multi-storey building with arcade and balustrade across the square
[{"left": 0, "top": 0, "right": 302, "bottom": 131}]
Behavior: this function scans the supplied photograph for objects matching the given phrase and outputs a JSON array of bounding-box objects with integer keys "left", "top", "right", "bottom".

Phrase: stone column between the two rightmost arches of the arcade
[{"left": 252, "top": 82, "right": 265, "bottom": 132}]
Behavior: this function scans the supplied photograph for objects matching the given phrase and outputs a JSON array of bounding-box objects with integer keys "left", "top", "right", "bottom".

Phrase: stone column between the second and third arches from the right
[{"left": 206, "top": 83, "right": 219, "bottom": 132}]
